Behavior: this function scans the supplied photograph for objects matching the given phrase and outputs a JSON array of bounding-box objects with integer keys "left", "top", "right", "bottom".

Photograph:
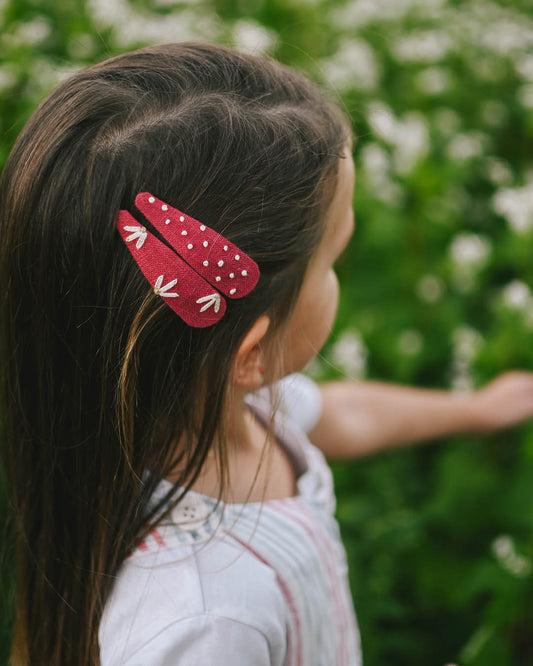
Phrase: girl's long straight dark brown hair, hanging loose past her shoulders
[{"left": 0, "top": 43, "right": 350, "bottom": 666}]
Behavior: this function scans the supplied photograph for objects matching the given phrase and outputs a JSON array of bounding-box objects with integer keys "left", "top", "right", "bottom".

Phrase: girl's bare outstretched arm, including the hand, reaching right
[{"left": 309, "top": 370, "right": 533, "bottom": 459}]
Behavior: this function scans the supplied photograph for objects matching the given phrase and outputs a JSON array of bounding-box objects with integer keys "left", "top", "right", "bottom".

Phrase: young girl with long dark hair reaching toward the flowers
[{"left": 0, "top": 43, "right": 533, "bottom": 666}]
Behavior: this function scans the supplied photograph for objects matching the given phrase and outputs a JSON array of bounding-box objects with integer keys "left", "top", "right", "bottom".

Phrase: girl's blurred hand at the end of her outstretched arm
[{"left": 468, "top": 370, "right": 533, "bottom": 433}]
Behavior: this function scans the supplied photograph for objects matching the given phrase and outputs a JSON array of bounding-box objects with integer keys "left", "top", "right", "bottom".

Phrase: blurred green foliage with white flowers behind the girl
[{"left": 0, "top": 0, "right": 533, "bottom": 666}]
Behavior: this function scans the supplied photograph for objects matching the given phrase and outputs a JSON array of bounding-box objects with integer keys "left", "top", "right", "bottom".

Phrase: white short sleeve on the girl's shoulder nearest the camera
[{"left": 99, "top": 525, "right": 287, "bottom": 666}]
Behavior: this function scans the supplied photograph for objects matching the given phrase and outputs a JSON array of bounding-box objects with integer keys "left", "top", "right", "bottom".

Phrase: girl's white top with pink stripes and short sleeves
[{"left": 99, "top": 373, "right": 361, "bottom": 666}]
